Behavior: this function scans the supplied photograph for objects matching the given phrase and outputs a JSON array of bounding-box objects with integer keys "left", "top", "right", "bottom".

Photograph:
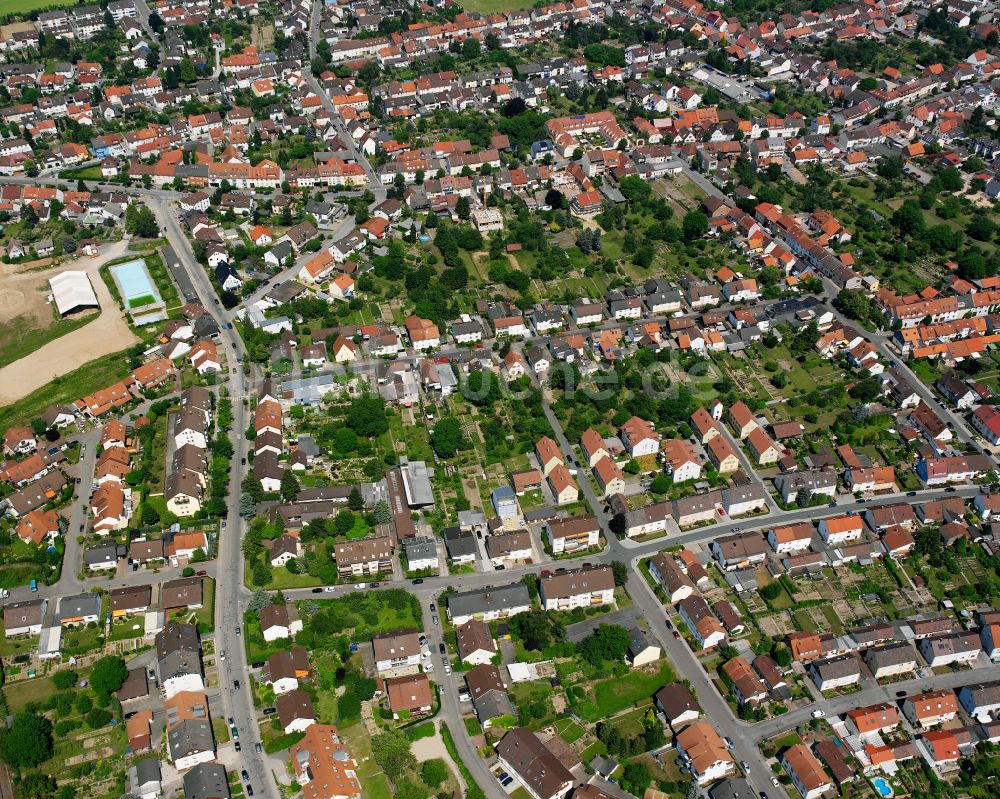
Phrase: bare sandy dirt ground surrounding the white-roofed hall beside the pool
[{"left": 0, "top": 242, "right": 139, "bottom": 405}]
